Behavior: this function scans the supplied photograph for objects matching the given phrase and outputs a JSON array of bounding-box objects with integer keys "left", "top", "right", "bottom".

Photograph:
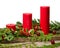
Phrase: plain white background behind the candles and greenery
[{"left": 0, "top": 0, "right": 60, "bottom": 27}]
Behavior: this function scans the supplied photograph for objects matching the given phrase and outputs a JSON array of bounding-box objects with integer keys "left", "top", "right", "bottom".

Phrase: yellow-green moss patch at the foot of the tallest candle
[{"left": 30, "top": 31, "right": 53, "bottom": 42}]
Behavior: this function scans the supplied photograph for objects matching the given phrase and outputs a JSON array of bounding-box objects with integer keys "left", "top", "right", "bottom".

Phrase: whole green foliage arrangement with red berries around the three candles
[{"left": 0, "top": 19, "right": 60, "bottom": 48}]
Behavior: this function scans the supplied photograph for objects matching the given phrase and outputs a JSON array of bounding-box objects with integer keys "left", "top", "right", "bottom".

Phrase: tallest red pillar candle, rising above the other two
[{"left": 40, "top": 6, "right": 50, "bottom": 34}]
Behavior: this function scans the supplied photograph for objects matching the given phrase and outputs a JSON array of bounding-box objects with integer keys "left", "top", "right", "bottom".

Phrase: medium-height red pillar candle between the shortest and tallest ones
[{"left": 23, "top": 13, "right": 32, "bottom": 30}]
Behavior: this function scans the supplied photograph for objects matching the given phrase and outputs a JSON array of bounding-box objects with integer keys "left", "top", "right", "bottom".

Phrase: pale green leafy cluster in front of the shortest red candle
[{"left": 0, "top": 28, "right": 19, "bottom": 41}]
